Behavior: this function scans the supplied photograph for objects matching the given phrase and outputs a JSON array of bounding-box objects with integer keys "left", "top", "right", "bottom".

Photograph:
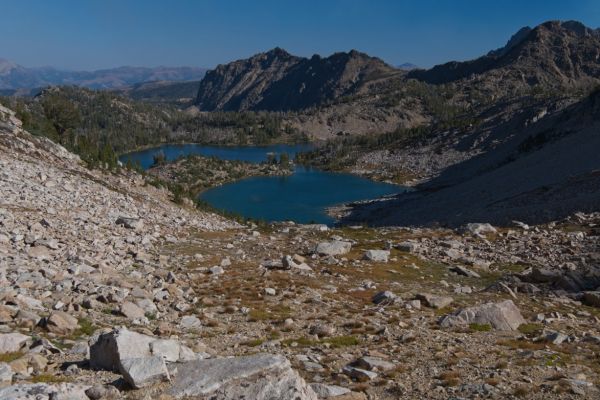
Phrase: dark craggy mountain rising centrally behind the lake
[{"left": 196, "top": 48, "right": 398, "bottom": 111}]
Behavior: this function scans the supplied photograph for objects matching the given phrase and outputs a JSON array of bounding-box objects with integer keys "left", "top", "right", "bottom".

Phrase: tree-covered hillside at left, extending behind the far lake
[{"left": 0, "top": 86, "right": 305, "bottom": 168}]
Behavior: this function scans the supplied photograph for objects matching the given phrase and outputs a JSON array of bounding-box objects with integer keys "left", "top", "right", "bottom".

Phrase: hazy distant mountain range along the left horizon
[{"left": 0, "top": 59, "right": 207, "bottom": 90}]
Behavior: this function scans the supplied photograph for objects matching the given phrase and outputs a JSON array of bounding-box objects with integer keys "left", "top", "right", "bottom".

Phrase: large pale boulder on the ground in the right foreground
[{"left": 440, "top": 300, "right": 525, "bottom": 331}]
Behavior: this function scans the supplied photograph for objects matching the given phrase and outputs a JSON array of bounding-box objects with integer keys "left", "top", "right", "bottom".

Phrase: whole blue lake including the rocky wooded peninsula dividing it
[{"left": 121, "top": 143, "right": 406, "bottom": 225}]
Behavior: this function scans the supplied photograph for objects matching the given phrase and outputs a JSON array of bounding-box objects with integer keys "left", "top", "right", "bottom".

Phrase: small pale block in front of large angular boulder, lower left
[{"left": 120, "top": 356, "right": 171, "bottom": 389}]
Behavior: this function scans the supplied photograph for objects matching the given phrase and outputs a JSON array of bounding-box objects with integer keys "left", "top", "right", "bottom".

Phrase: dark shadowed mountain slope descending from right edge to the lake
[{"left": 347, "top": 91, "right": 600, "bottom": 225}]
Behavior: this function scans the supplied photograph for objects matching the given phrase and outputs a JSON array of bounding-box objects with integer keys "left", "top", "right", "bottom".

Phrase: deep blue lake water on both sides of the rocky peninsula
[{"left": 120, "top": 144, "right": 406, "bottom": 225}]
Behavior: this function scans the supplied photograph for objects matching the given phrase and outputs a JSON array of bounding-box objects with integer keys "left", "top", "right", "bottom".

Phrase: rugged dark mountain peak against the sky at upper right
[{"left": 408, "top": 21, "right": 600, "bottom": 88}]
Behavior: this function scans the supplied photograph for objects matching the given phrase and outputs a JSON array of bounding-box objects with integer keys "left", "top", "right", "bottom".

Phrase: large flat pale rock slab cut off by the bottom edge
[{"left": 167, "top": 354, "right": 317, "bottom": 400}]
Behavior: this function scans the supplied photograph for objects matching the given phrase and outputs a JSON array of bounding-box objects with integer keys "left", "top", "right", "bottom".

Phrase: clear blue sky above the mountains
[{"left": 0, "top": 0, "right": 600, "bottom": 69}]
